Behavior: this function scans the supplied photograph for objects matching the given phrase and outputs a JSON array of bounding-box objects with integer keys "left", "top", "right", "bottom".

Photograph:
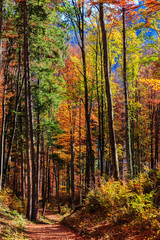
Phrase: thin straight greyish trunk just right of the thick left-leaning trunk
[{"left": 122, "top": 8, "right": 133, "bottom": 178}]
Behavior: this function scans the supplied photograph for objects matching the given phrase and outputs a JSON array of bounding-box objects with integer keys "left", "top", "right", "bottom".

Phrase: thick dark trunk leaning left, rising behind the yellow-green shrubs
[{"left": 99, "top": 3, "right": 119, "bottom": 179}]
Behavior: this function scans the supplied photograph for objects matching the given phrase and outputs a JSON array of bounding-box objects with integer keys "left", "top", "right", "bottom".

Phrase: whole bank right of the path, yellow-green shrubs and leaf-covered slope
[{"left": 65, "top": 170, "right": 160, "bottom": 239}]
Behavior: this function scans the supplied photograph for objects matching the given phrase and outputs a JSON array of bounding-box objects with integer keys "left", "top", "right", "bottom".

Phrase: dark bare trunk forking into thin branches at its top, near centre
[{"left": 66, "top": 0, "right": 95, "bottom": 193}]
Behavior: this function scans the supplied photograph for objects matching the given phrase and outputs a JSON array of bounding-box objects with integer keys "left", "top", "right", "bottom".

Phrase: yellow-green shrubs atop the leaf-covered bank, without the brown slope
[{"left": 86, "top": 171, "right": 160, "bottom": 225}]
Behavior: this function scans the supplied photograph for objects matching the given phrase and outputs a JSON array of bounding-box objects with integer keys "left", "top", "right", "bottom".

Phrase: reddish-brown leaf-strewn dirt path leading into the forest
[{"left": 26, "top": 211, "right": 85, "bottom": 240}]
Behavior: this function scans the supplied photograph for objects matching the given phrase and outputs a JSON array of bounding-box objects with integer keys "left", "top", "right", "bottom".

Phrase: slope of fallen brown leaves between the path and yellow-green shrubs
[{"left": 63, "top": 207, "right": 160, "bottom": 240}]
